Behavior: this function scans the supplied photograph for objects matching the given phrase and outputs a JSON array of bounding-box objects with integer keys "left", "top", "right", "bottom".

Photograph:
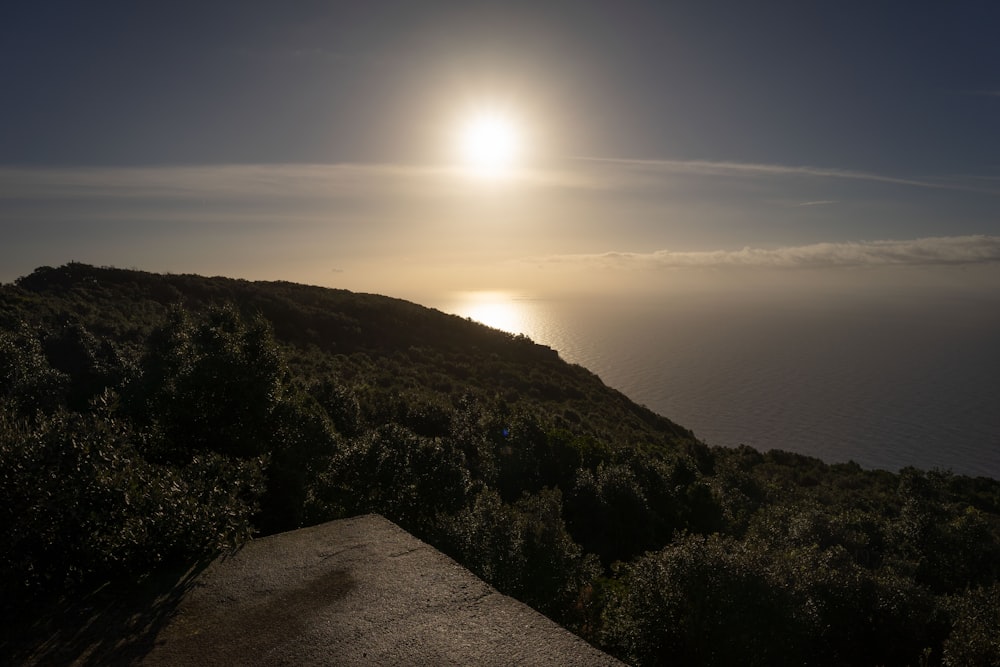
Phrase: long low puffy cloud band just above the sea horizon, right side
[{"left": 524, "top": 235, "right": 1000, "bottom": 269}]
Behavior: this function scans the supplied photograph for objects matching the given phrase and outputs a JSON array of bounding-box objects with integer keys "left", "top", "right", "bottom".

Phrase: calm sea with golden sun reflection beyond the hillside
[{"left": 428, "top": 292, "right": 1000, "bottom": 479}]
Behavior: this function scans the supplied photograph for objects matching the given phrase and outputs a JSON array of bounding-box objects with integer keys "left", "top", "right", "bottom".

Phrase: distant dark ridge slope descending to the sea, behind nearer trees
[{"left": 0, "top": 264, "right": 692, "bottom": 448}]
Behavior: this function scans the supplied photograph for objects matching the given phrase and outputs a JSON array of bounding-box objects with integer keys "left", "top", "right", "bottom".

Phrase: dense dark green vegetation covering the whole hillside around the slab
[{"left": 0, "top": 264, "right": 1000, "bottom": 666}]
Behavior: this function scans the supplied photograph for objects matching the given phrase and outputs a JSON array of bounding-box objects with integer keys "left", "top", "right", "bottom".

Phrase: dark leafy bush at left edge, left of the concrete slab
[{"left": 0, "top": 404, "right": 261, "bottom": 604}]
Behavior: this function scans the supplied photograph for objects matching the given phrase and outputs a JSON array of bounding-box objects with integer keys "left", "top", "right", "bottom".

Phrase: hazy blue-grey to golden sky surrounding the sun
[{"left": 0, "top": 0, "right": 1000, "bottom": 300}]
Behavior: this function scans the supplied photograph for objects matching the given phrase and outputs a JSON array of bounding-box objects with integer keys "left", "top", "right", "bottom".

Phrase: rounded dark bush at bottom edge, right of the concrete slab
[{"left": 604, "top": 535, "right": 805, "bottom": 665}]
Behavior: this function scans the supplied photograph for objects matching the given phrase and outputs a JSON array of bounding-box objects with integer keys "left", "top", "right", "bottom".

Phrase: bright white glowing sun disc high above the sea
[{"left": 457, "top": 110, "right": 523, "bottom": 175}]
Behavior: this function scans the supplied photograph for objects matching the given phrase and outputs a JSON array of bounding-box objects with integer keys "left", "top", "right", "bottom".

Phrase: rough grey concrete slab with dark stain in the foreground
[{"left": 142, "top": 515, "right": 621, "bottom": 666}]
